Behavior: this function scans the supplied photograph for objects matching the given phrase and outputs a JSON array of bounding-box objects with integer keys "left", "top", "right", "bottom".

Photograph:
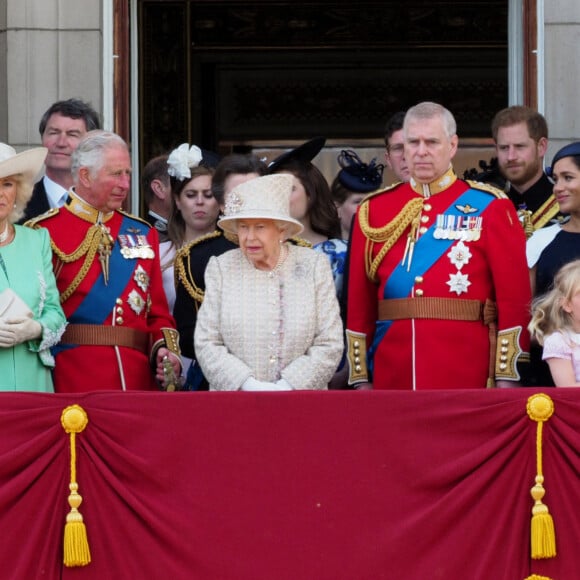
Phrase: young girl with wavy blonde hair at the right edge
[{"left": 528, "top": 260, "right": 580, "bottom": 387}]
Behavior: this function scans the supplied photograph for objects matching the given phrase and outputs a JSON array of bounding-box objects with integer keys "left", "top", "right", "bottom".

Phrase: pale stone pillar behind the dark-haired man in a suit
[{"left": 0, "top": 0, "right": 103, "bottom": 148}]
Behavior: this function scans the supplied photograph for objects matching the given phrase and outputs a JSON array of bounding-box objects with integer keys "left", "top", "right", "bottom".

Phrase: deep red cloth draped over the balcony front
[{"left": 0, "top": 389, "right": 580, "bottom": 580}]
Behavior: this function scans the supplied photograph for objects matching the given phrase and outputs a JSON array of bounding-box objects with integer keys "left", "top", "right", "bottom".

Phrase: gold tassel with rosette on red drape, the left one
[{"left": 60, "top": 405, "right": 91, "bottom": 568}]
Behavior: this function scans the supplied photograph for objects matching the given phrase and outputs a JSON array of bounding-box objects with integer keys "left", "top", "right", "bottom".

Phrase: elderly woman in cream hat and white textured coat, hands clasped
[{"left": 195, "top": 174, "right": 343, "bottom": 391}]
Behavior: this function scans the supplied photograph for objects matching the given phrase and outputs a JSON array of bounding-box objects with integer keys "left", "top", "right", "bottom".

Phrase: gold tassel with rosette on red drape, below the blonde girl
[{"left": 527, "top": 393, "right": 556, "bottom": 560}]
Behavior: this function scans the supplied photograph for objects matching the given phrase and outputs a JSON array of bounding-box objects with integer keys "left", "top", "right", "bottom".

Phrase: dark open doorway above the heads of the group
[{"left": 139, "top": 0, "right": 508, "bottom": 165}]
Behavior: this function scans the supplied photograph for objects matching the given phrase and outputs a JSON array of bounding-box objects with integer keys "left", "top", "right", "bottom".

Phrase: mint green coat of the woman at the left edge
[{"left": 0, "top": 225, "right": 66, "bottom": 392}]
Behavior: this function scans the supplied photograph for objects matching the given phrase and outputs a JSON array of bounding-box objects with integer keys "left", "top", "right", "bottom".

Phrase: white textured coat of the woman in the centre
[{"left": 195, "top": 245, "right": 343, "bottom": 390}]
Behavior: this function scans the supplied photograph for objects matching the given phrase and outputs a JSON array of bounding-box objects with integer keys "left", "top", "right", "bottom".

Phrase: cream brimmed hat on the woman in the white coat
[{"left": 218, "top": 173, "right": 304, "bottom": 238}]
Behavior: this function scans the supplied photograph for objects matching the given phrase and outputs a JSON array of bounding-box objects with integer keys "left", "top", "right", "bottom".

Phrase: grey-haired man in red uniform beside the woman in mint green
[{"left": 27, "top": 131, "right": 181, "bottom": 393}]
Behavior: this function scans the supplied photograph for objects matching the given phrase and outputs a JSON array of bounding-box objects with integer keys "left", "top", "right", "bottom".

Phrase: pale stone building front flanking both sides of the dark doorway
[{"left": 0, "top": 0, "right": 580, "bottom": 207}]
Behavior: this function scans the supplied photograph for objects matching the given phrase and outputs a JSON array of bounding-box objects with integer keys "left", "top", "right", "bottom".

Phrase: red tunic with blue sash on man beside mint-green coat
[{"left": 31, "top": 193, "right": 179, "bottom": 393}]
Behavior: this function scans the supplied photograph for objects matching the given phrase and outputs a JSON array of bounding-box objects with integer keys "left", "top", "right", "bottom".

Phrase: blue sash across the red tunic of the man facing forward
[{"left": 367, "top": 189, "right": 495, "bottom": 373}]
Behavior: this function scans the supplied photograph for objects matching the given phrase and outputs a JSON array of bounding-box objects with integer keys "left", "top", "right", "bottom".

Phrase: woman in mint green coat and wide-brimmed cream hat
[{"left": 0, "top": 143, "right": 66, "bottom": 392}]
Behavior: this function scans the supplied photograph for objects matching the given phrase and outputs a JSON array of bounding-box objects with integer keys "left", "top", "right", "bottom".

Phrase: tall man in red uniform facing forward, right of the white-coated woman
[{"left": 346, "top": 103, "right": 530, "bottom": 390}]
